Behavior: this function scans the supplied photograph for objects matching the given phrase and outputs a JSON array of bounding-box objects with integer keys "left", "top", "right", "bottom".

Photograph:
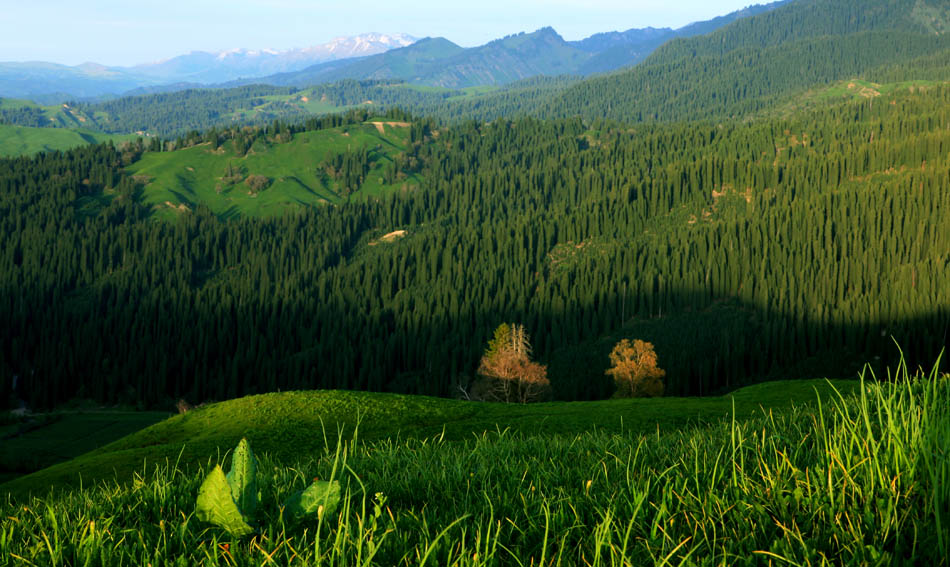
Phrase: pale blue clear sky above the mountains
[{"left": 0, "top": 0, "right": 767, "bottom": 65}]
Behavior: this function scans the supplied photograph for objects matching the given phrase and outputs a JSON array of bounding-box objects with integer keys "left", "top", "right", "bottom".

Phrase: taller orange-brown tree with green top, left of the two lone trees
[{"left": 472, "top": 323, "right": 551, "bottom": 404}]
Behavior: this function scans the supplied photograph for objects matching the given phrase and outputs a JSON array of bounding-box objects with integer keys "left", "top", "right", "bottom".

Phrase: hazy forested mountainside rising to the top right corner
[{"left": 541, "top": 0, "right": 950, "bottom": 121}]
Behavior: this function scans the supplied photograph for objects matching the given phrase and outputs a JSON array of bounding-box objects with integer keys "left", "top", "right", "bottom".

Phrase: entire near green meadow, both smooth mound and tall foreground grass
[{"left": 0, "top": 364, "right": 950, "bottom": 566}]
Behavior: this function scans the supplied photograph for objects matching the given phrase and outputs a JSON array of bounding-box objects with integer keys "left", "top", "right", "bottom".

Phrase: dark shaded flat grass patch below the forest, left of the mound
[{"left": 0, "top": 410, "right": 169, "bottom": 481}]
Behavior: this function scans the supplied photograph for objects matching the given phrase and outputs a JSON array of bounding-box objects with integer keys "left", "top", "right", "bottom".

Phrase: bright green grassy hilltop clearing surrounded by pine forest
[{"left": 128, "top": 124, "right": 416, "bottom": 218}]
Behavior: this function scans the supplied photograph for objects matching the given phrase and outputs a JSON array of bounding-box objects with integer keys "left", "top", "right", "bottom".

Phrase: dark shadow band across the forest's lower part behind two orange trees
[{"left": 0, "top": 274, "right": 950, "bottom": 407}]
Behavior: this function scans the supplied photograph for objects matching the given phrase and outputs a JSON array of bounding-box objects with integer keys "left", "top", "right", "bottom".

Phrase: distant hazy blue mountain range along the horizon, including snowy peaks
[{"left": 0, "top": 0, "right": 788, "bottom": 103}]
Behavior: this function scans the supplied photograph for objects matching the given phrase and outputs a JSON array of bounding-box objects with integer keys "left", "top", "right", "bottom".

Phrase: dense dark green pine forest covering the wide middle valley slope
[{"left": 0, "top": 77, "right": 950, "bottom": 407}]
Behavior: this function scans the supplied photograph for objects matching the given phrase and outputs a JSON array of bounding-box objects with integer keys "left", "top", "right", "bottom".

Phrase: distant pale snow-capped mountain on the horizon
[{"left": 127, "top": 33, "right": 416, "bottom": 83}]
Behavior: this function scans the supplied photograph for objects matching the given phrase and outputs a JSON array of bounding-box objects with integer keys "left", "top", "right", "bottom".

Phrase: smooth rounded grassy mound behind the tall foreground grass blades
[{"left": 0, "top": 380, "right": 855, "bottom": 495}]
